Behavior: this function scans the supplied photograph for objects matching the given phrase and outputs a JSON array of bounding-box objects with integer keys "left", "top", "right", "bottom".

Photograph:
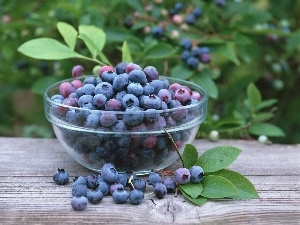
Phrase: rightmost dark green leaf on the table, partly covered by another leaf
[{"left": 213, "top": 169, "right": 259, "bottom": 199}]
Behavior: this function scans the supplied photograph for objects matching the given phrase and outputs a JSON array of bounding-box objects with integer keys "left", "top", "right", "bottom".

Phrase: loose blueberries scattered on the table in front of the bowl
[{"left": 53, "top": 163, "right": 204, "bottom": 210}]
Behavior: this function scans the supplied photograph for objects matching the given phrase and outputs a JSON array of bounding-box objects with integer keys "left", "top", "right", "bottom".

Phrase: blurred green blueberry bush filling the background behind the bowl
[{"left": 0, "top": 0, "right": 300, "bottom": 143}]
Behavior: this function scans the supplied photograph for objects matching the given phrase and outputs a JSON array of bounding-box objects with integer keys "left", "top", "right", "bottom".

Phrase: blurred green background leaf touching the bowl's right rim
[{"left": 191, "top": 70, "right": 219, "bottom": 98}]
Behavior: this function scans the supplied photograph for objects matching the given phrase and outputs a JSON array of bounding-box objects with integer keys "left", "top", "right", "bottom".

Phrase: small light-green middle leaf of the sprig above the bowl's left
[{"left": 57, "top": 22, "right": 78, "bottom": 50}]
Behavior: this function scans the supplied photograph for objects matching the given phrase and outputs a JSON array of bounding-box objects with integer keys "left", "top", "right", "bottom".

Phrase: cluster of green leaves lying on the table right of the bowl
[{"left": 179, "top": 144, "right": 259, "bottom": 205}]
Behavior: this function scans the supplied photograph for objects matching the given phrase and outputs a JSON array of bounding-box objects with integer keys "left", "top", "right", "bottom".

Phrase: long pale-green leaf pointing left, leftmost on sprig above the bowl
[{"left": 18, "top": 38, "right": 79, "bottom": 60}]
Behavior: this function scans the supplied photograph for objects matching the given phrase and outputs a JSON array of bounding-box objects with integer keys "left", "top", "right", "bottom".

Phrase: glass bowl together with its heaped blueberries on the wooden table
[{"left": 44, "top": 62, "right": 208, "bottom": 174}]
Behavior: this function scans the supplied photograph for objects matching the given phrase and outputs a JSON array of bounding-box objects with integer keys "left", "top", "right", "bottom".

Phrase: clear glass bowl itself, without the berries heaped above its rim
[{"left": 44, "top": 76, "right": 208, "bottom": 174}]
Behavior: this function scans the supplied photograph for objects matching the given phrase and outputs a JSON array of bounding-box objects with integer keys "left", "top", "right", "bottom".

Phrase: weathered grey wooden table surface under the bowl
[{"left": 0, "top": 137, "right": 300, "bottom": 224}]
